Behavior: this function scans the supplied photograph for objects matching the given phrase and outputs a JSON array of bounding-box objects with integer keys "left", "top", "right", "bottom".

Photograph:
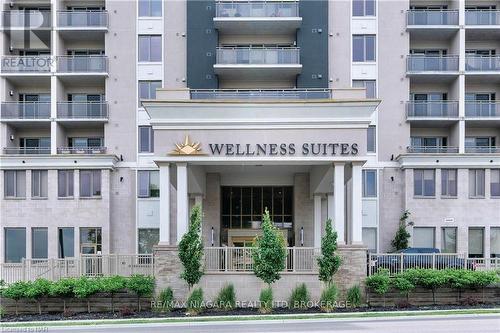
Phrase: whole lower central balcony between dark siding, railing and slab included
[{"left": 214, "top": 47, "right": 302, "bottom": 79}]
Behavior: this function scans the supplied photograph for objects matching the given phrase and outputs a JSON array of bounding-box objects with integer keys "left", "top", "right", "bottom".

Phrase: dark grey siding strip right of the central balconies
[{"left": 297, "top": 0, "right": 328, "bottom": 88}]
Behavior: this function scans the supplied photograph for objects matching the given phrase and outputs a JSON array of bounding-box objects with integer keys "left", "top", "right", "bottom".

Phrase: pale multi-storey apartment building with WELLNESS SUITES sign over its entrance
[{"left": 0, "top": 0, "right": 500, "bottom": 262}]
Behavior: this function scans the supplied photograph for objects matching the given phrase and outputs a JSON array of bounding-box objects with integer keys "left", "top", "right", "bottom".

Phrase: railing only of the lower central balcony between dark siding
[{"left": 217, "top": 47, "right": 300, "bottom": 65}]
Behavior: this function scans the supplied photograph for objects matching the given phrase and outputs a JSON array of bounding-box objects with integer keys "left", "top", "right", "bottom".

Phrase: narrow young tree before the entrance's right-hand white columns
[{"left": 318, "top": 219, "right": 342, "bottom": 286}]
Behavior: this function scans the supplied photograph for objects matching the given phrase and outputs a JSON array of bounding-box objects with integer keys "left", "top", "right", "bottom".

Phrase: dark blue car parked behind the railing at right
[{"left": 371, "top": 247, "right": 475, "bottom": 273}]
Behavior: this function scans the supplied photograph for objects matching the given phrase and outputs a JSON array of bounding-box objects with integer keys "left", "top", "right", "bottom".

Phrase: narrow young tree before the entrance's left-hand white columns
[{"left": 179, "top": 205, "right": 203, "bottom": 290}]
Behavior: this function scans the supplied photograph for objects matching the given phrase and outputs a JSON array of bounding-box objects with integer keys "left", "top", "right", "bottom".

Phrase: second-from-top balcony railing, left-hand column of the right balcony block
[{"left": 406, "top": 55, "right": 458, "bottom": 73}]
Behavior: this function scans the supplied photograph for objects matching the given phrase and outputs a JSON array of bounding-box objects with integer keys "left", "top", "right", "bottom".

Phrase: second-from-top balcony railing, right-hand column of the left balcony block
[{"left": 57, "top": 55, "right": 108, "bottom": 73}]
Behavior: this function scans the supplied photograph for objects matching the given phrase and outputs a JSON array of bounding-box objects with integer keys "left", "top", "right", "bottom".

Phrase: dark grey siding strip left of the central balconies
[{"left": 188, "top": 0, "right": 217, "bottom": 89}]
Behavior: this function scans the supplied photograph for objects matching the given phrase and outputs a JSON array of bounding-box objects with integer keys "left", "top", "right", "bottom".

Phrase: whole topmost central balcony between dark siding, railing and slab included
[{"left": 214, "top": 1, "right": 302, "bottom": 35}]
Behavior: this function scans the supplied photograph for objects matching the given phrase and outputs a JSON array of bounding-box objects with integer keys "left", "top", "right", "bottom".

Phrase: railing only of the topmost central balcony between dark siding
[{"left": 215, "top": 1, "right": 299, "bottom": 18}]
